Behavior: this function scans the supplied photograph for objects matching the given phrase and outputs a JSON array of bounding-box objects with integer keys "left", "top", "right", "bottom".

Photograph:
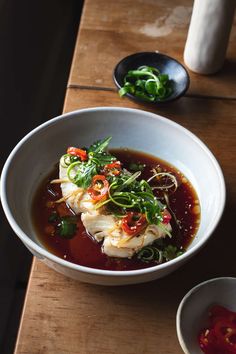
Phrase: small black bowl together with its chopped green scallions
[{"left": 113, "top": 52, "right": 189, "bottom": 103}]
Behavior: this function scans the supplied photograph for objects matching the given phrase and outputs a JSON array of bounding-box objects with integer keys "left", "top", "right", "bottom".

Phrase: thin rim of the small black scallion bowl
[{"left": 112, "top": 51, "right": 190, "bottom": 105}]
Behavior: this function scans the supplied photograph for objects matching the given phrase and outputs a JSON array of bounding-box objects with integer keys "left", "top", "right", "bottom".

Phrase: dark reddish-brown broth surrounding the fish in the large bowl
[{"left": 32, "top": 149, "right": 200, "bottom": 270}]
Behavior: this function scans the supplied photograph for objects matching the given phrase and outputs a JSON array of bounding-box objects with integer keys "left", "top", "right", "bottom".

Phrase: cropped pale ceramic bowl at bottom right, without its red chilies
[{"left": 176, "top": 277, "right": 236, "bottom": 354}]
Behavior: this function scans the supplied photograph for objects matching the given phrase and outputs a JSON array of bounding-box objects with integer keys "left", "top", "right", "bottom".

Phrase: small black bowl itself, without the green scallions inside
[{"left": 113, "top": 52, "right": 190, "bottom": 104}]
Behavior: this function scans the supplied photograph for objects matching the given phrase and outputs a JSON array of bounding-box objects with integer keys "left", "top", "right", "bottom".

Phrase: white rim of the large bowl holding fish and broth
[{"left": 0, "top": 106, "right": 226, "bottom": 277}]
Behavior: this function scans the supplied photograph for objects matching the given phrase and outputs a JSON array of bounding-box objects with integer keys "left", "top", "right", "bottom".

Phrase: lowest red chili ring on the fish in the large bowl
[{"left": 121, "top": 211, "right": 147, "bottom": 236}]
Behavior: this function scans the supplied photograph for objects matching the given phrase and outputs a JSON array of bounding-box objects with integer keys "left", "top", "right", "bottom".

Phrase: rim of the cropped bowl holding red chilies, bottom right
[{"left": 176, "top": 276, "right": 236, "bottom": 353}]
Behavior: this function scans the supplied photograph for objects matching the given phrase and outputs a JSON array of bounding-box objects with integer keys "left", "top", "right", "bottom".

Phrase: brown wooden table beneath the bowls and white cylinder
[{"left": 15, "top": 0, "right": 236, "bottom": 354}]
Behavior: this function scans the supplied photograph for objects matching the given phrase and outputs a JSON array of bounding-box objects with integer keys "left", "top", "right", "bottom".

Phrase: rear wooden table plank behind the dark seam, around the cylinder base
[{"left": 69, "top": 0, "right": 236, "bottom": 98}]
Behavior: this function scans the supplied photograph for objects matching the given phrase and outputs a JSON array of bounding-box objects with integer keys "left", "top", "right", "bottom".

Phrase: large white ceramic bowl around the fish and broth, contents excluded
[{"left": 1, "top": 107, "right": 225, "bottom": 285}]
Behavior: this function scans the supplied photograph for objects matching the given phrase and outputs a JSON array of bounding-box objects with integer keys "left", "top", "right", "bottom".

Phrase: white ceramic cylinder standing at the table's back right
[{"left": 184, "top": 0, "right": 236, "bottom": 74}]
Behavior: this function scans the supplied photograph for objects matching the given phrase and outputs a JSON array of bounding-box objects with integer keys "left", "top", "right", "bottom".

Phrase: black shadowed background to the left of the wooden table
[{"left": 0, "top": 0, "right": 83, "bottom": 354}]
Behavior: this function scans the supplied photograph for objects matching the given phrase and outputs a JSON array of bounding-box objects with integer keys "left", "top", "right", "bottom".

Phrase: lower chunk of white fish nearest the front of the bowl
[{"left": 81, "top": 213, "right": 171, "bottom": 258}]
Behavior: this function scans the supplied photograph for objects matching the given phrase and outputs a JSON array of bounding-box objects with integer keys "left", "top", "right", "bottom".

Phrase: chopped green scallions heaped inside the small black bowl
[{"left": 119, "top": 65, "right": 173, "bottom": 102}]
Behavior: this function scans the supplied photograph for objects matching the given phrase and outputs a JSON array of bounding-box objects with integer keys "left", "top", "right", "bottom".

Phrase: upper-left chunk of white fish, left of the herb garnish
[{"left": 59, "top": 163, "right": 98, "bottom": 214}]
